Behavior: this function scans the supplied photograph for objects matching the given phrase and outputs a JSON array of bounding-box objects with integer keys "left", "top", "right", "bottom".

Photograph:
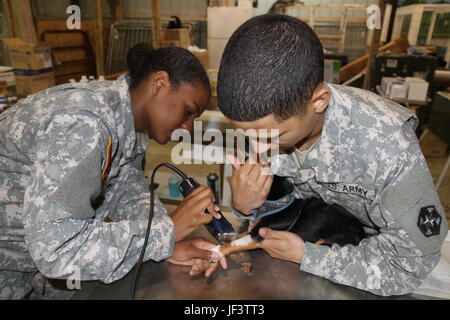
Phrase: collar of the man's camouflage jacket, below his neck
[{"left": 271, "top": 82, "right": 342, "bottom": 183}]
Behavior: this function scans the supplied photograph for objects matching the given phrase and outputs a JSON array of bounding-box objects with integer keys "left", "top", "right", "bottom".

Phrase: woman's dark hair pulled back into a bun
[{"left": 127, "top": 43, "right": 211, "bottom": 94}]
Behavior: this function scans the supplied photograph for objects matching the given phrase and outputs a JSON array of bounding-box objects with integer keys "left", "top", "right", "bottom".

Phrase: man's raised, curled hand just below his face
[{"left": 227, "top": 155, "right": 273, "bottom": 214}]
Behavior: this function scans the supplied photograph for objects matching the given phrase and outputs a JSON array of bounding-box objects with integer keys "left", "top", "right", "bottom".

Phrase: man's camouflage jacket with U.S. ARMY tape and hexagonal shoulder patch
[{"left": 237, "top": 84, "right": 448, "bottom": 295}]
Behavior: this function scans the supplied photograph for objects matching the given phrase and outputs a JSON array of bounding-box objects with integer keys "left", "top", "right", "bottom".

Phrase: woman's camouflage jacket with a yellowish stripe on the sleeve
[{"left": 0, "top": 76, "right": 175, "bottom": 299}]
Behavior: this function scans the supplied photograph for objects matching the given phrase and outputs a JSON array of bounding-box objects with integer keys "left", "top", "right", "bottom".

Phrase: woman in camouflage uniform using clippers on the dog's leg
[{"left": 0, "top": 45, "right": 225, "bottom": 299}]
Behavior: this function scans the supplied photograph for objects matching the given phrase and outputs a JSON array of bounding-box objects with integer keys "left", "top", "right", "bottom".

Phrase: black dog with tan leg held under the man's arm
[{"left": 214, "top": 176, "right": 367, "bottom": 255}]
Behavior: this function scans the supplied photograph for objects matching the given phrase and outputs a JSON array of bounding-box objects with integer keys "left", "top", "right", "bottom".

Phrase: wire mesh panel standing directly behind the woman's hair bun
[{"left": 106, "top": 20, "right": 152, "bottom": 74}]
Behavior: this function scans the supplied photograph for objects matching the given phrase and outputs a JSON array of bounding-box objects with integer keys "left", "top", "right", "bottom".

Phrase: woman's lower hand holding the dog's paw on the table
[{"left": 167, "top": 238, "right": 227, "bottom": 277}]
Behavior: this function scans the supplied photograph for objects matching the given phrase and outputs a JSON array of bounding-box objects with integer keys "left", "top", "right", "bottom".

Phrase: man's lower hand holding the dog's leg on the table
[{"left": 259, "top": 228, "right": 305, "bottom": 263}]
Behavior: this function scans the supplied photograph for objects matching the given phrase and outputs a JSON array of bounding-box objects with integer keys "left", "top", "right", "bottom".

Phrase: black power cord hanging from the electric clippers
[{"left": 131, "top": 163, "right": 188, "bottom": 300}]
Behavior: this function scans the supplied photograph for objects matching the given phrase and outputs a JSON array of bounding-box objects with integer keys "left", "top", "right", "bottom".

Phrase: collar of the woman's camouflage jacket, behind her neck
[{"left": 115, "top": 74, "right": 144, "bottom": 161}]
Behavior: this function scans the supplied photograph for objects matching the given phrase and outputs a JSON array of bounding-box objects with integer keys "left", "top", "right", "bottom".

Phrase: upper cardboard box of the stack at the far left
[{"left": 2, "top": 38, "right": 53, "bottom": 70}]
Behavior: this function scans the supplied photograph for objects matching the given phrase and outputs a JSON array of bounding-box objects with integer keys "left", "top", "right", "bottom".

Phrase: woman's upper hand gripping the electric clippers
[{"left": 170, "top": 186, "right": 221, "bottom": 241}]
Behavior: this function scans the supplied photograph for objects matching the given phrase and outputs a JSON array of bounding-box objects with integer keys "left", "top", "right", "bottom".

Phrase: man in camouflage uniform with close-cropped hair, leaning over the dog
[{"left": 218, "top": 15, "right": 448, "bottom": 295}]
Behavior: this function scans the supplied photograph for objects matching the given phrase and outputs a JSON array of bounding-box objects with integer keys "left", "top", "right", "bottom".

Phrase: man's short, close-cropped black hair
[{"left": 217, "top": 14, "right": 324, "bottom": 121}]
